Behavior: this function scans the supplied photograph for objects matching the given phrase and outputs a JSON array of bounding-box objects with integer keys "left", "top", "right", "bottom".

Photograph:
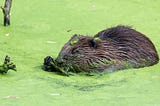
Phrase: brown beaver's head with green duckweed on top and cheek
[{"left": 56, "top": 35, "right": 110, "bottom": 70}]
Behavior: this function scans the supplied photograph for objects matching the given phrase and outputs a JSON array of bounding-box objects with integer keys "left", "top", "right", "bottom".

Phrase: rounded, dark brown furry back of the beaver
[{"left": 94, "top": 26, "right": 159, "bottom": 69}]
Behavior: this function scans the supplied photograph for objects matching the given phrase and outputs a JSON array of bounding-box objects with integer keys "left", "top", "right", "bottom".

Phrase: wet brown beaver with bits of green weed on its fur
[{"left": 44, "top": 25, "right": 159, "bottom": 75}]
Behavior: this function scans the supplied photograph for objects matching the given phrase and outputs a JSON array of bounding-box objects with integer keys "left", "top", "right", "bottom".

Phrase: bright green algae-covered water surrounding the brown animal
[{"left": 0, "top": 0, "right": 160, "bottom": 106}]
